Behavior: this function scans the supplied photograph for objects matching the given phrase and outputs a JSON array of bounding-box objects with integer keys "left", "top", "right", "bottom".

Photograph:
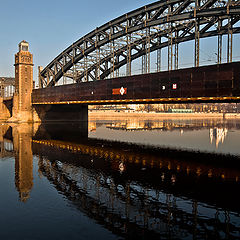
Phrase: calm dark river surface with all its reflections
[{"left": 0, "top": 118, "right": 240, "bottom": 240}]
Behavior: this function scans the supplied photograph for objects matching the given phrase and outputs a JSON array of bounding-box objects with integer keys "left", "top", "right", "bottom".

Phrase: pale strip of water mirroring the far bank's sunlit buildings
[{"left": 89, "top": 117, "right": 240, "bottom": 155}]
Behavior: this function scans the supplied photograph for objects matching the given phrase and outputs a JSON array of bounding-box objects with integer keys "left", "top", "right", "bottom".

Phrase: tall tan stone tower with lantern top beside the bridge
[{"left": 11, "top": 41, "right": 33, "bottom": 122}]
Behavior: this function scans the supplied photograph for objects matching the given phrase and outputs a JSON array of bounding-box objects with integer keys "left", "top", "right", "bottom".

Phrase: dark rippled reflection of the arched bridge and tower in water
[{"left": 1, "top": 125, "right": 240, "bottom": 239}]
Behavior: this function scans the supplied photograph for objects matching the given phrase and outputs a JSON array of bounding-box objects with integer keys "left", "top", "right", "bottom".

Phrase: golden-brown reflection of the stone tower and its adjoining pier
[{"left": 0, "top": 124, "right": 33, "bottom": 202}]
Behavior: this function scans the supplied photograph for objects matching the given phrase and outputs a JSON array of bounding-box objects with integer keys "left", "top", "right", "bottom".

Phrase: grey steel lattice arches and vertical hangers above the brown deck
[{"left": 39, "top": 0, "right": 240, "bottom": 87}]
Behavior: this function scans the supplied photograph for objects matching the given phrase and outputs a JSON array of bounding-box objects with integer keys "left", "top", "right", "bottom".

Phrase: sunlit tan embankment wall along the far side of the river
[{"left": 89, "top": 110, "right": 240, "bottom": 120}]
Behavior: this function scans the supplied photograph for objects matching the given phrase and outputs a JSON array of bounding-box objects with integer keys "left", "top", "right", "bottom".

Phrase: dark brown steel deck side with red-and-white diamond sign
[{"left": 32, "top": 62, "right": 240, "bottom": 104}]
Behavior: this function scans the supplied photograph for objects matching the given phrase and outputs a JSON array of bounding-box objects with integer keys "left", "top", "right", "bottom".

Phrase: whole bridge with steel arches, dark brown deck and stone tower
[{"left": 0, "top": 0, "right": 240, "bottom": 121}]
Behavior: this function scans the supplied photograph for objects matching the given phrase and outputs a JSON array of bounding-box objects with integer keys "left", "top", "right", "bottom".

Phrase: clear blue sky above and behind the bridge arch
[{"left": 0, "top": 0, "right": 240, "bottom": 80}]
